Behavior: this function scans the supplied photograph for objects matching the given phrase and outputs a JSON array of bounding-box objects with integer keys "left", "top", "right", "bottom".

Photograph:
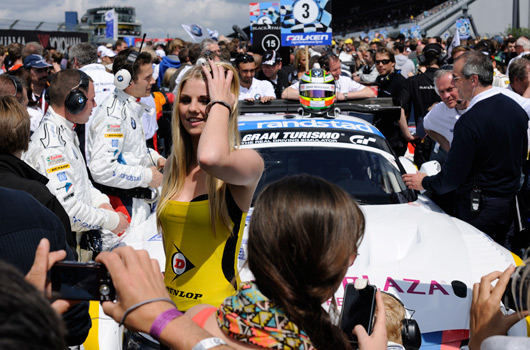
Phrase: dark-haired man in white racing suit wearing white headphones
[{"left": 87, "top": 49, "right": 165, "bottom": 226}]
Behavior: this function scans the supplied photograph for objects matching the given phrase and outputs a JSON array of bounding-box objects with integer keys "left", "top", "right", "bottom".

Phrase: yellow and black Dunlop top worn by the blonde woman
[{"left": 160, "top": 188, "right": 247, "bottom": 311}]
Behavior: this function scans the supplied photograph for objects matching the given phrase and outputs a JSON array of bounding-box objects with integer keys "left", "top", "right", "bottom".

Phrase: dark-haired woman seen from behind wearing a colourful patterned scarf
[{"left": 186, "top": 175, "right": 387, "bottom": 350}]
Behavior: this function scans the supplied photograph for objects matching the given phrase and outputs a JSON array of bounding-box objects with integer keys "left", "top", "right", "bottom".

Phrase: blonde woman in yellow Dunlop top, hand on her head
[{"left": 157, "top": 60, "right": 263, "bottom": 311}]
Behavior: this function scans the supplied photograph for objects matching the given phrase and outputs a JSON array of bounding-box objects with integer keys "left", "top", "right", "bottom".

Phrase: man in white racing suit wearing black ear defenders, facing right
[{"left": 24, "top": 69, "right": 129, "bottom": 261}]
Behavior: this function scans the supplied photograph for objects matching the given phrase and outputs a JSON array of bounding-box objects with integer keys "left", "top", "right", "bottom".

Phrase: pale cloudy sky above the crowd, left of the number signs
[{"left": 0, "top": 0, "right": 250, "bottom": 40}]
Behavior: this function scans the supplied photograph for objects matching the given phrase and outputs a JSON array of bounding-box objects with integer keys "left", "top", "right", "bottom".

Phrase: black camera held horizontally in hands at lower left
[{"left": 51, "top": 261, "right": 116, "bottom": 301}]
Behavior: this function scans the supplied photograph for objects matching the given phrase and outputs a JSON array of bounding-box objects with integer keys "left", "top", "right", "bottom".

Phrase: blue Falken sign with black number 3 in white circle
[{"left": 280, "top": 0, "right": 332, "bottom": 46}]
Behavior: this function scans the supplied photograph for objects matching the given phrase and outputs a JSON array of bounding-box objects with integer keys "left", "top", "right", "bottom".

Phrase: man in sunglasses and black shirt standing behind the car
[{"left": 375, "top": 47, "right": 407, "bottom": 156}]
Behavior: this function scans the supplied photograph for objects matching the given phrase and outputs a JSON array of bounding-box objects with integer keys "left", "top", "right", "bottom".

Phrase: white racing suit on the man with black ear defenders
[{"left": 24, "top": 107, "right": 120, "bottom": 232}]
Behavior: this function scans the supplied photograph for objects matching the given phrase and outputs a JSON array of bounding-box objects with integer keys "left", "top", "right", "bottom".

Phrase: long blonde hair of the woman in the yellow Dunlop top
[{"left": 156, "top": 62, "right": 240, "bottom": 233}]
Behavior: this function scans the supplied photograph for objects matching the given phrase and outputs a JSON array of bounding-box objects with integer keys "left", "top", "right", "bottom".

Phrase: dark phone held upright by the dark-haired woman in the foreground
[{"left": 340, "top": 279, "right": 377, "bottom": 343}]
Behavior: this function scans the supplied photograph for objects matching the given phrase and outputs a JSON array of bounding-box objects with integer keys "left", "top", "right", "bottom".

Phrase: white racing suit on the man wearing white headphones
[{"left": 87, "top": 89, "right": 162, "bottom": 226}]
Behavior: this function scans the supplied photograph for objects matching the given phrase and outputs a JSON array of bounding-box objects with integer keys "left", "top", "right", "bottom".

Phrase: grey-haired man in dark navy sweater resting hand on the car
[{"left": 403, "top": 51, "right": 528, "bottom": 249}]
